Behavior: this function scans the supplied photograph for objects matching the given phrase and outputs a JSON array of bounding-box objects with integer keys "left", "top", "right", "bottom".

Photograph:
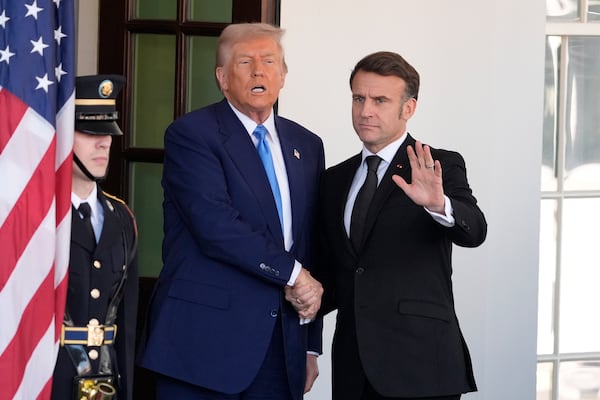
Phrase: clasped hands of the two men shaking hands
[{"left": 285, "top": 268, "right": 323, "bottom": 320}]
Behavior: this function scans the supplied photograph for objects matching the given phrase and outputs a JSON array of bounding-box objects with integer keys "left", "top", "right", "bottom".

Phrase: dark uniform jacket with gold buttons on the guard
[{"left": 52, "top": 188, "right": 138, "bottom": 400}]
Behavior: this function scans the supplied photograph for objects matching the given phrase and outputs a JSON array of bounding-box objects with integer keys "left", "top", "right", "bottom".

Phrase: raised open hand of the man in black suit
[{"left": 392, "top": 141, "right": 445, "bottom": 214}]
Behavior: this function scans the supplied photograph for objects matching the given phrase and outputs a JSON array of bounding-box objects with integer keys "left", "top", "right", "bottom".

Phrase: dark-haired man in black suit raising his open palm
[{"left": 315, "top": 52, "right": 487, "bottom": 400}]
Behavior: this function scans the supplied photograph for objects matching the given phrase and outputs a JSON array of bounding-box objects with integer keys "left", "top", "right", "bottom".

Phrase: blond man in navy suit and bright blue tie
[{"left": 141, "top": 24, "right": 324, "bottom": 400}]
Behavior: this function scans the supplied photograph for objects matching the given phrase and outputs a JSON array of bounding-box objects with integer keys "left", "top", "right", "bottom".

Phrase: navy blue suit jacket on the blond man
[{"left": 141, "top": 100, "right": 324, "bottom": 398}]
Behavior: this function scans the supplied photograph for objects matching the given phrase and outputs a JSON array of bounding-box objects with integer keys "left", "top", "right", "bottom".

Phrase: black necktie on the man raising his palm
[{"left": 350, "top": 156, "right": 381, "bottom": 250}]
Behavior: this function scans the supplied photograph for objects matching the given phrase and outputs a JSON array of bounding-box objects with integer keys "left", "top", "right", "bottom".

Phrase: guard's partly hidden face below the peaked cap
[{"left": 73, "top": 131, "right": 112, "bottom": 180}]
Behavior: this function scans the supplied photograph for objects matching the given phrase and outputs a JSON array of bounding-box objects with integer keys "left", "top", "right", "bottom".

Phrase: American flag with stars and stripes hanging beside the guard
[{"left": 0, "top": 0, "right": 75, "bottom": 400}]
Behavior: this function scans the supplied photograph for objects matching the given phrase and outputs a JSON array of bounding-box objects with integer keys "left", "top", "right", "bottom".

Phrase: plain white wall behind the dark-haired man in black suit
[{"left": 279, "top": 0, "right": 545, "bottom": 400}]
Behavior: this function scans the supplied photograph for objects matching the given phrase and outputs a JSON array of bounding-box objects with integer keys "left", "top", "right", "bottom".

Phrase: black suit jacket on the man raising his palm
[{"left": 316, "top": 135, "right": 487, "bottom": 400}]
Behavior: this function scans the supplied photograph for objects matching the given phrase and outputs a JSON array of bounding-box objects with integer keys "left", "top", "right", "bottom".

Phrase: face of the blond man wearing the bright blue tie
[{"left": 216, "top": 37, "right": 285, "bottom": 122}]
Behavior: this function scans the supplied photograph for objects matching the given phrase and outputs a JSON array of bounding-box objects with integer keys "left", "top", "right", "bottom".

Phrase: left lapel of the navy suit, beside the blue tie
[{"left": 217, "top": 100, "right": 283, "bottom": 246}]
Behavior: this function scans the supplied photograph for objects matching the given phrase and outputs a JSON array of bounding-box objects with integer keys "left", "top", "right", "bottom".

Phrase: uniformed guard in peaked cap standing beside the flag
[{"left": 52, "top": 75, "right": 138, "bottom": 400}]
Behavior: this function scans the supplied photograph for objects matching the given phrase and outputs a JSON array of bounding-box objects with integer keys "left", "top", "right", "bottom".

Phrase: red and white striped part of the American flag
[{"left": 0, "top": 86, "right": 74, "bottom": 400}]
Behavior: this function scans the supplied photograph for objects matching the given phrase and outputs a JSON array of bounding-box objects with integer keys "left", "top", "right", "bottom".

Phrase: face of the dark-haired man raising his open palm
[{"left": 352, "top": 71, "right": 417, "bottom": 153}]
